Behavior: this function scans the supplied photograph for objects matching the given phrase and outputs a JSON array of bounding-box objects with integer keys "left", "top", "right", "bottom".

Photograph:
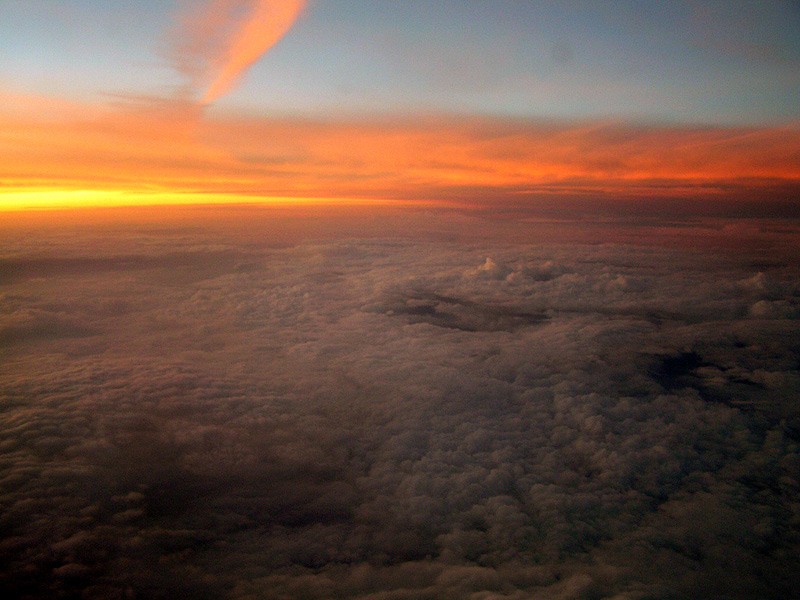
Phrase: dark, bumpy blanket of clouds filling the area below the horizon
[{"left": 0, "top": 205, "right": 800, "bottom": 599}]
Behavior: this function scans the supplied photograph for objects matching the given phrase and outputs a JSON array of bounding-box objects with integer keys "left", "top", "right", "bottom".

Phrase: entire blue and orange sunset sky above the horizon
[{"left": 0, "top": 0, "right": 800, "bottom": 208}]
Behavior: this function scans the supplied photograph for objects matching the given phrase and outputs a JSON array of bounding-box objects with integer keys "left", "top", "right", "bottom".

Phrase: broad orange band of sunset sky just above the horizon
[{"left": 0, "top": 89, "right": 800, "bottom": 209}]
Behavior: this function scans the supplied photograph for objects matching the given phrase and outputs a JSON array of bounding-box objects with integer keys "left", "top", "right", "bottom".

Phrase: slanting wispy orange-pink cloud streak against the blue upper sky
[{"left": 173, "top": 0, "right": 306, "bottom": 104}]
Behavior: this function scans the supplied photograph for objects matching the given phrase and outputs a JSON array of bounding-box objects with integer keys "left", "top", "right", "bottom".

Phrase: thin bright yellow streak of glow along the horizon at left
[{"left": 0, "top": 189, "right": 431, "bottom": 212}]
